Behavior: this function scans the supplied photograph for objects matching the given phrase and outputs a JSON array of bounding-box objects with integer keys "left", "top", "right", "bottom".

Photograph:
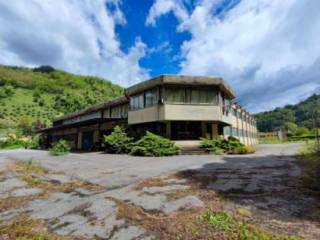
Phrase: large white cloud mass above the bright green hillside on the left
[{"left": 0, "top": 0, "right": 149, "bottom": 86}]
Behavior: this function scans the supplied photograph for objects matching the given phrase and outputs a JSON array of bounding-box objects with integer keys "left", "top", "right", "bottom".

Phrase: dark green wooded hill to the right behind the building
[{"left": 255, "top": 94, "right": 320, "bottom": 132}]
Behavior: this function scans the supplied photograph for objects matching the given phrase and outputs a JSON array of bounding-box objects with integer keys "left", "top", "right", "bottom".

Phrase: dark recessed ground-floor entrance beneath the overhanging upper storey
[{"left": 171, "top": 121, "right": 202, "bottom": 140}]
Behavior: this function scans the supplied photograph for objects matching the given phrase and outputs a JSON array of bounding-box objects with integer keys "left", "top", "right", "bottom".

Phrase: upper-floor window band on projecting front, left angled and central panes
[{"left": 130, "top": 87, "right": 218, "bottom": 109}]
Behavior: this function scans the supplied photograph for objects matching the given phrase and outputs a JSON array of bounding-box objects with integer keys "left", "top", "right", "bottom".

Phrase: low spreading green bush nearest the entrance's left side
[{"left": 130, "top": 131, "right": 179, "bottom": 157}]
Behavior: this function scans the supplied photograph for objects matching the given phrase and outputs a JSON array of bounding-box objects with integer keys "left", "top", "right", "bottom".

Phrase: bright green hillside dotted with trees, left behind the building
[{"left": 0, "top": 65, "right": 123, "bottom": 136}]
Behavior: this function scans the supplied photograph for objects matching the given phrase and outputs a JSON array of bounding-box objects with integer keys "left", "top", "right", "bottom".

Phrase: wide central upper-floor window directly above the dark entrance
[{"left": 164, "top": 87, "right": 217, "bottom": 104}]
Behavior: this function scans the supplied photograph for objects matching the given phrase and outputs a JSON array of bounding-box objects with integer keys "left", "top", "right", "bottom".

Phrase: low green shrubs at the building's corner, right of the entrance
[{"left": 200, "top": 136, "right": 255, "bottom": 155}]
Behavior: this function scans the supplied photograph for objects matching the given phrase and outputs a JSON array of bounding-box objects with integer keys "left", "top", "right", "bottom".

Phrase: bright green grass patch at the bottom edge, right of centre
[{"left": 200, "top": 210, "right": 300, "bottom": 240}]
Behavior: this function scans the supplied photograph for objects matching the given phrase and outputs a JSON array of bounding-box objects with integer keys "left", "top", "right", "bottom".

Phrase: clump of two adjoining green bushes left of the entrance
[{"left": 105, "top": 126, "right": 179, "bottom": 157}]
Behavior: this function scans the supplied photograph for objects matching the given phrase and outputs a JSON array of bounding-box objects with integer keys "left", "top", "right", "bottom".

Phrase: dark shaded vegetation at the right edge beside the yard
[{"left": 298, "top": 143, "right": 320, "bottom": 195}]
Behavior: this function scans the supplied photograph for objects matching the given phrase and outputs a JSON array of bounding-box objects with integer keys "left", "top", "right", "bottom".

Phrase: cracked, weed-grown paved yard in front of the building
[{"left": 0, "top": 144, "right": 320, "bottom": 239}]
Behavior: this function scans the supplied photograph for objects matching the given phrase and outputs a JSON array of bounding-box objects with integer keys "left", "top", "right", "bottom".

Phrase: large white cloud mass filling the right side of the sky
[{"left": 147, "top": 0, "right": 320, "bottom": 111}]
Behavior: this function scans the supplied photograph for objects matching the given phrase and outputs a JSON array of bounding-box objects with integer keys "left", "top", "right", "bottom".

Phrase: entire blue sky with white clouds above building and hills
[{"left": 0, "top": 0, "right": 320, "bottom": 113}]
